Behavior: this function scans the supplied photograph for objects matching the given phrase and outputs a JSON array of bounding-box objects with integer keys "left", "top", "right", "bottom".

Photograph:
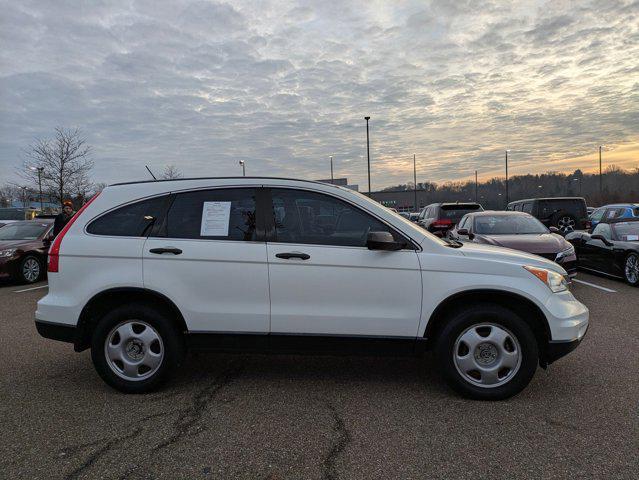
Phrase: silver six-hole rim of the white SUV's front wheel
[{"left": 453, "top": 323, "right": 522, "bottom": 388}]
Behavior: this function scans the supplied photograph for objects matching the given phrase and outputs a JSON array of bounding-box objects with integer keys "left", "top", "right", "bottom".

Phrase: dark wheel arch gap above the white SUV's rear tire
[{"left": 74, "top": 287, "right": 188, "bottom": 352}]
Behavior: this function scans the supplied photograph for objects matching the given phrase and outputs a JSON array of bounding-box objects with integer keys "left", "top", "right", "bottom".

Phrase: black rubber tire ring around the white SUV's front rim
[{"left": 435, "top": 304, "right": 539, "bottom": 400}]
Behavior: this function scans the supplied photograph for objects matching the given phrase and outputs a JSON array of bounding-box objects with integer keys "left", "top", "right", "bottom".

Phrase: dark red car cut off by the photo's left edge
[{"left": 0, "top": 219, "right": 53, "bottom": 283}]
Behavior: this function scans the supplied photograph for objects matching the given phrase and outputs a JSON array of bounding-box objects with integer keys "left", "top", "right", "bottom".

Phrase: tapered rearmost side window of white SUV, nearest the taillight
[{"left": 87, "top": 195, "right": 167, "bottom": 237}]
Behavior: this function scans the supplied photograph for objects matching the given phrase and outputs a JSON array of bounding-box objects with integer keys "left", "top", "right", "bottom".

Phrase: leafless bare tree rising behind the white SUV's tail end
[{"left": 20, "top": 127, "right": 93, "bottom": 204}]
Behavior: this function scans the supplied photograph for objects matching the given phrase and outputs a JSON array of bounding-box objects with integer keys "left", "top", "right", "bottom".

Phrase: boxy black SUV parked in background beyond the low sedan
[{"left": 506, "top": 197, "right": 590, "bottom": 234}]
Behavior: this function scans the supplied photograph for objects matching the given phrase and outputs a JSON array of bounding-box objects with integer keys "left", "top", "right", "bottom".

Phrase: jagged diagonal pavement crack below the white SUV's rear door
[{"left": 153, "top": 363, "right": 242, "bottom": 451}]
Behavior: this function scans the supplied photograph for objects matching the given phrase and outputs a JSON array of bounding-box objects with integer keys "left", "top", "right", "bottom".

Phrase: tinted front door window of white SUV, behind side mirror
[{"left": 271, "top": 189, "right": 406, "bottom": 247}]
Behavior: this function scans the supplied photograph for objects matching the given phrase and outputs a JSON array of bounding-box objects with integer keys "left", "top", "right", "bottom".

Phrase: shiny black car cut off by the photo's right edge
[{"left": 566, "top": 218, "right": 639, "bottom": 287}]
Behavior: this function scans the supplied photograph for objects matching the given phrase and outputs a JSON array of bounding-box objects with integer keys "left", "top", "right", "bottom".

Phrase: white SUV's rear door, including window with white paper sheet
[{"left": 143, "top": 187, "right": 269, "bottom": 334}]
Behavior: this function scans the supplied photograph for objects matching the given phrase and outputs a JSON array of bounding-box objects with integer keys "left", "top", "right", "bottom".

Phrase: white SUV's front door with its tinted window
[{"left": 266, "top": 188, "right": 422, "bottom": 342}]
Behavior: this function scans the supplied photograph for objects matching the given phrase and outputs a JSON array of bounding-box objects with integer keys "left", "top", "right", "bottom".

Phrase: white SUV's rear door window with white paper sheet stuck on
[{"left": 166, "top": 188, "right": 256, "bottom": 241}]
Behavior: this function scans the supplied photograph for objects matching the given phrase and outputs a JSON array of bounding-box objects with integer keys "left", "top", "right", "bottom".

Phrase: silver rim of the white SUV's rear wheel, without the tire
[{"left": 104, "top": 320, "right": 164, "bottom": 381}]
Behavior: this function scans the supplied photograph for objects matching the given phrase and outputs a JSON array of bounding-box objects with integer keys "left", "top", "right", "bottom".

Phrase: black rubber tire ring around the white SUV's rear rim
[{"left": 91, "top": 303, "right": 185, "bottom": 393}]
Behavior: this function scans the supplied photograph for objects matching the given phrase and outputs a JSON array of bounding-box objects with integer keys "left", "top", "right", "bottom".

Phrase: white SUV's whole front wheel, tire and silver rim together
[{"left": 436, "top": 305, "right": 539, "bottom": 400}]
